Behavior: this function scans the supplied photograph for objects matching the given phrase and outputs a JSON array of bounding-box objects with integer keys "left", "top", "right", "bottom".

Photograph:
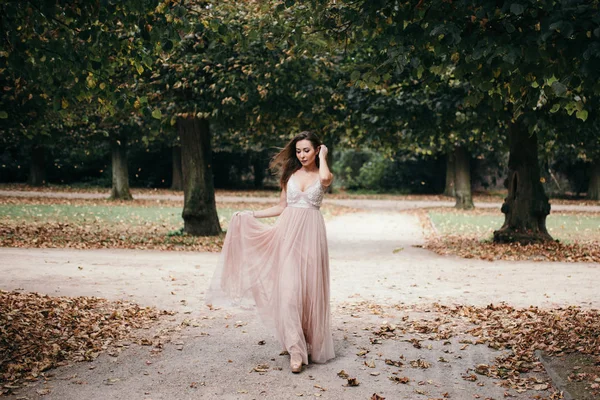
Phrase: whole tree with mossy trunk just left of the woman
[{"left": 149, "top": 1, "right": 342, "bottom": 235}]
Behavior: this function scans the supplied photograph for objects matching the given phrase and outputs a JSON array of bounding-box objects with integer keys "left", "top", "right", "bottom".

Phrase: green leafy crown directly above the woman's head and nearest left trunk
[{"left": 148, "top": 0, "right": 340, "bottom": 150}]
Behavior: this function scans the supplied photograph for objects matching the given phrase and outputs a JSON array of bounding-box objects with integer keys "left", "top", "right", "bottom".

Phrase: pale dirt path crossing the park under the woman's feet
[{"left": 0, "top": 210, "right": 600, "bottom": 399}]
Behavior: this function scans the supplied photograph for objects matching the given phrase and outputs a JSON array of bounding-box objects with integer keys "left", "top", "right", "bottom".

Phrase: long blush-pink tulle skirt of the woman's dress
[{"left": 207, "top": 207, "right": 335, "bottom": 364}]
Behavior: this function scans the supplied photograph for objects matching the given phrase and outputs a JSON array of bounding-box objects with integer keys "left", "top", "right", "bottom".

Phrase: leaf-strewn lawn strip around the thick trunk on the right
[{"left": 419, "top": 209, "right": 600, "bottom": 262}]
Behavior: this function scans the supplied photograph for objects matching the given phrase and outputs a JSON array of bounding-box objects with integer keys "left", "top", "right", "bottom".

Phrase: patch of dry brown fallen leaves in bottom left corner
[{"left": 0, "top": 290, "right": 161, "bottom": 393}]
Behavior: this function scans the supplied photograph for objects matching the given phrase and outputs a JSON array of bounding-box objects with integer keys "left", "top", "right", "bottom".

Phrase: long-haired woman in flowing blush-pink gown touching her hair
[{"left": 207, "top": 132, "right": 334, "bottom": 373}]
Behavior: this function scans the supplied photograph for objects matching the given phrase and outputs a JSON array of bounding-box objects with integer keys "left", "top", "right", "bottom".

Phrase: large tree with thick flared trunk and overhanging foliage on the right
[{"left": 312, "top": 0, "right": 600, "bottom": 243}]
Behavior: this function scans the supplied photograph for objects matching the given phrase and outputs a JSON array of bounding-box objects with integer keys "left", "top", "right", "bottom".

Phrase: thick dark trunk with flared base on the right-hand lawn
[{"left": 494, "top": 122, "right": 552, "bottom": 244}]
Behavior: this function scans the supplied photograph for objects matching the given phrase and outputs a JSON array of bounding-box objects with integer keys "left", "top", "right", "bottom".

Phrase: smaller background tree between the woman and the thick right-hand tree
[{"left": 332, "top": 72, "right": 503, "bottom": 209}]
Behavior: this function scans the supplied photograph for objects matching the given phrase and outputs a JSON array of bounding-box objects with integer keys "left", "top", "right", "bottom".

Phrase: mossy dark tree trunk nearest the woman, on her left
[{"left": 177, "top": 117, "right": 221, "bottom": 236}]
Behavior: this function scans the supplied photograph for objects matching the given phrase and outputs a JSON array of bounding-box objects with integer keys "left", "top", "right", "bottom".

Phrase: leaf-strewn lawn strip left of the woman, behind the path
[{"left": 0, "top": 197, "right": 353, "bottom": 252}]
